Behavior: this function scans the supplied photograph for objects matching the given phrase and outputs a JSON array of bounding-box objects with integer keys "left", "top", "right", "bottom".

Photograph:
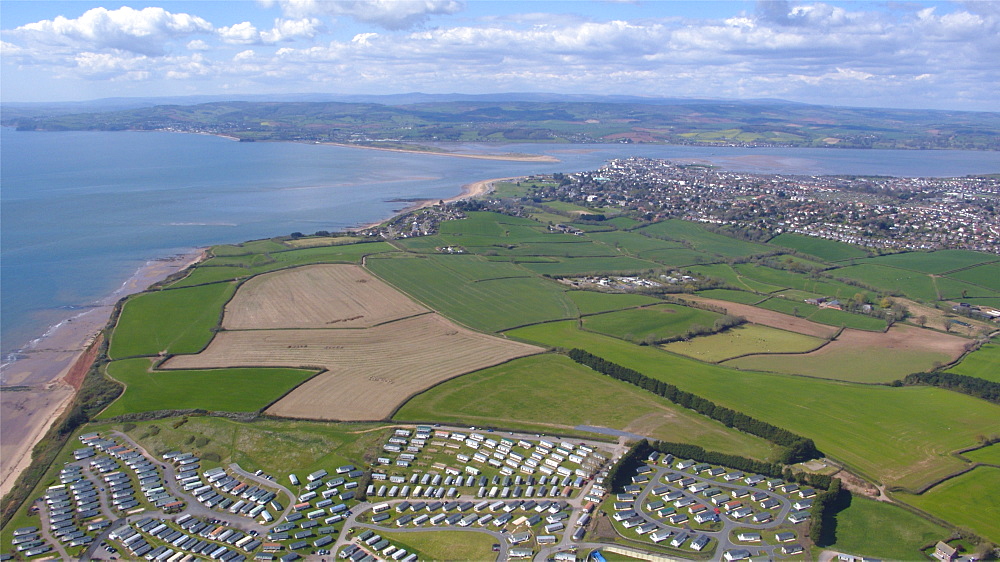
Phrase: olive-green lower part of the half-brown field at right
[{"left": 725, "top": 347, "right": 950, "bottom": 383}]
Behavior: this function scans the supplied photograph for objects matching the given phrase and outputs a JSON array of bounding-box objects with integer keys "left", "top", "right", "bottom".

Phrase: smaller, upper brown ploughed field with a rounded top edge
[{"left": 222, "top": 265, "right": 428, "bottom": 330}]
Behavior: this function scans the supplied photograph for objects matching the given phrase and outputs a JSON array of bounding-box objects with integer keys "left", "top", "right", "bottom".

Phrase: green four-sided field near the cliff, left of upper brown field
[{"left": 108, "top": 283, "right": 236, "bottom": 359}]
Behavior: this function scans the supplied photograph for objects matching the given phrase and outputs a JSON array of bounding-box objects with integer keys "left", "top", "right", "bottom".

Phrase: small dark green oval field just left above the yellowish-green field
[{"left": 583, "top": 304, "right": 722, "bottom": 342}]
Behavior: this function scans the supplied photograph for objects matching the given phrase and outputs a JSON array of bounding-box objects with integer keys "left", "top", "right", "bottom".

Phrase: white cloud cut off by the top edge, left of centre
[{"left": 279, "top": 0, "right": 463, "bottom": 30}]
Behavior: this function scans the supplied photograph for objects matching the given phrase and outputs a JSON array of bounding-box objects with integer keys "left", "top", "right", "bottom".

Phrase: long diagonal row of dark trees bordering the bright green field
[{"left": 568, "top": 349, "right": 821, "bottom": 464}]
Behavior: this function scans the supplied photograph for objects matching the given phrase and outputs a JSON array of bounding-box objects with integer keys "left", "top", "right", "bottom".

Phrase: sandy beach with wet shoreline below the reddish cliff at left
[{"left": 0, "top": 250, "right": 204, "bottom": 495}]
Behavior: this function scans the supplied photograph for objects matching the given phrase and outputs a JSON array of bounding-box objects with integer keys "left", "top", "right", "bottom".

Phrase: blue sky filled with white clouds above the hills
[{"left": 0, "top": 0, "right": 1000, "bottom": 111}]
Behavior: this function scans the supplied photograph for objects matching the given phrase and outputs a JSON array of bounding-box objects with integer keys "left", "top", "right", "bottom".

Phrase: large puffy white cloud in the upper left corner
[{"left": 12, "top": 6, "right": 212, "bottom": 56}]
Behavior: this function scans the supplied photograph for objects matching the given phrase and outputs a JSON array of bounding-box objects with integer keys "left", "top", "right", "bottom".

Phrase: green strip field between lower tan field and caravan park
[{"left": 100, "top": 358, "right": 315, "bottom": 418}]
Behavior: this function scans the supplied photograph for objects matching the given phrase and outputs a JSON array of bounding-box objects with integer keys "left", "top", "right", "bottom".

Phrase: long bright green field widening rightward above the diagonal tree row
[{"left": 508, "top": 322, "right": 1000, "bottom": 487}]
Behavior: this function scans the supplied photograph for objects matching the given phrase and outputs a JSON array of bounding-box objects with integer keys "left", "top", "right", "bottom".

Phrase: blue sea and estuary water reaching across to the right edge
[{"left": 0, "top": 128, "right": 1000, "bottom": 363}]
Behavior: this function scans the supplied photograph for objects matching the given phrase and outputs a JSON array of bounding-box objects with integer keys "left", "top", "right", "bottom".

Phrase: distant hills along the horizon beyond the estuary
[{"left": 2, "top": 93, "right": 1000, "bottom": 150}]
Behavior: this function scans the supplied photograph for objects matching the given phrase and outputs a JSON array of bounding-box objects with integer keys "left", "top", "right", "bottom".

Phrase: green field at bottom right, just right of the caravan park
[{"left": 829, "top": 495, "right": 951, "bottom": 560}]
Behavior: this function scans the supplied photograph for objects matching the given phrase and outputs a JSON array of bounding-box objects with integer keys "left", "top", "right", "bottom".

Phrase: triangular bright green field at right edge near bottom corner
[{"left": 896, "top": 466, "right": 1000, "bottom": 543}]
